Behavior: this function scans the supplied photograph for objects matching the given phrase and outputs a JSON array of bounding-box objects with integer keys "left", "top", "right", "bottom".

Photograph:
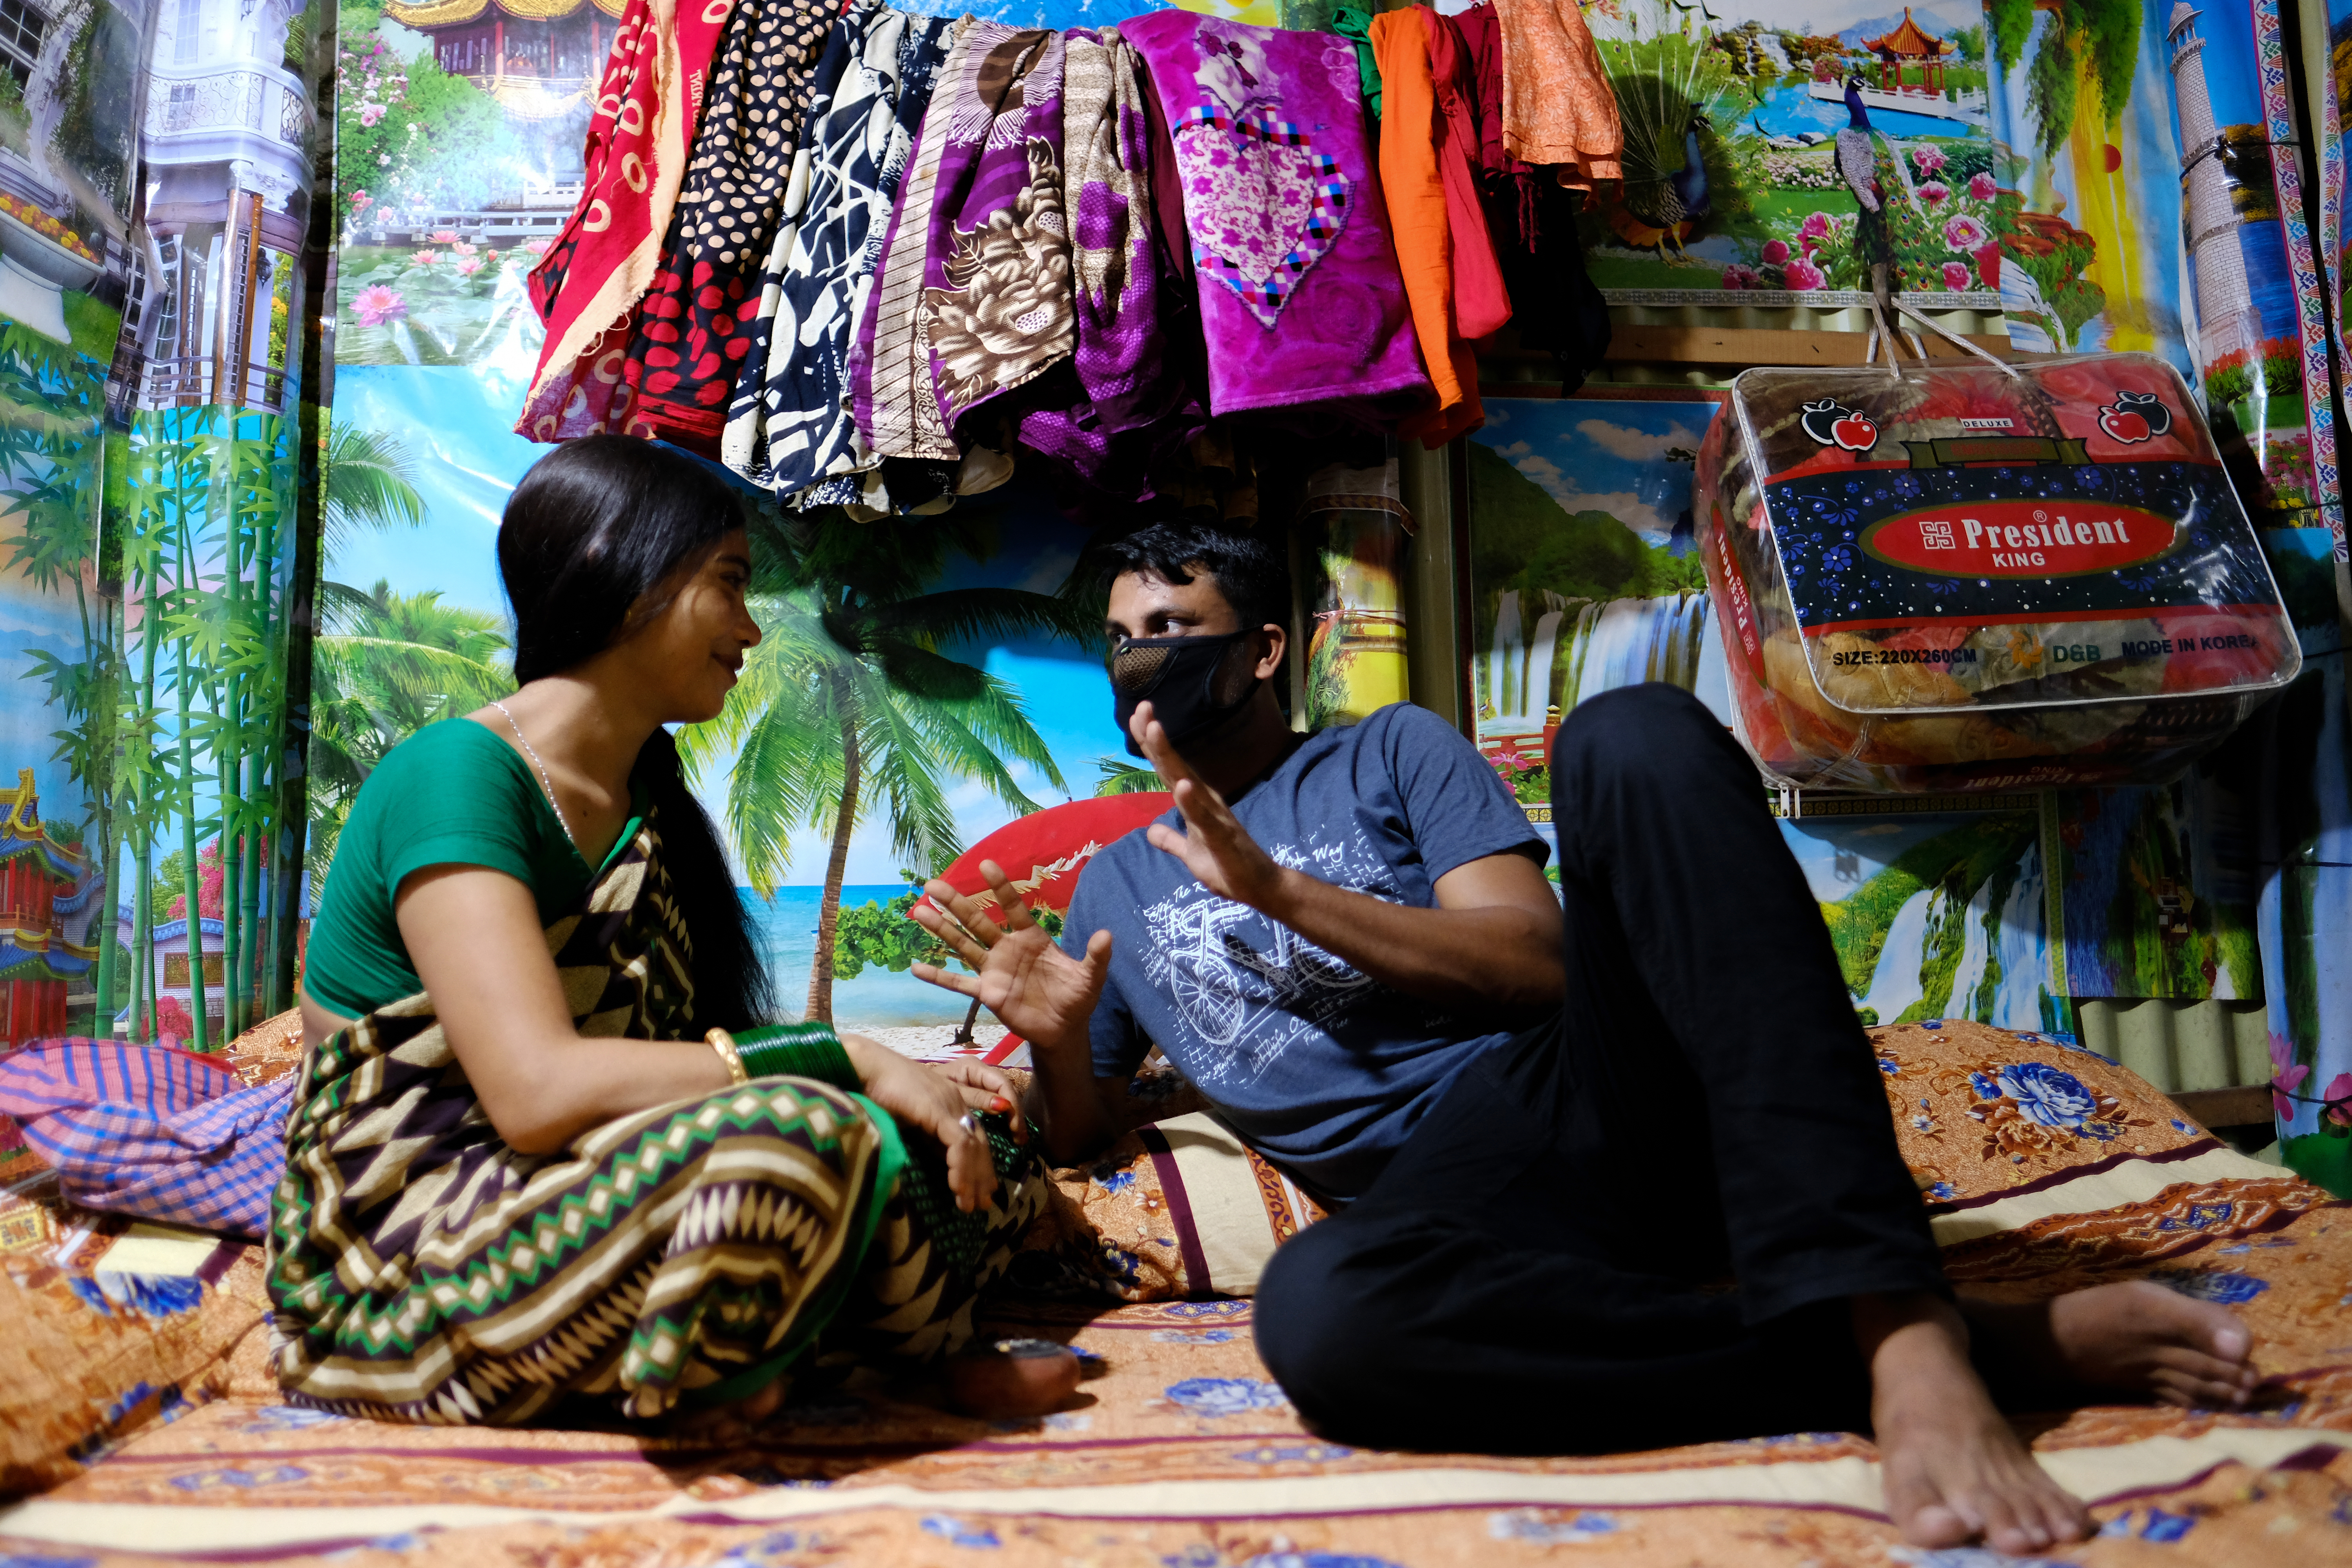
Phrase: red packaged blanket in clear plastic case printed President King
[{"left": 1696, "top": 355, "right": 2303, "bottom": 792}]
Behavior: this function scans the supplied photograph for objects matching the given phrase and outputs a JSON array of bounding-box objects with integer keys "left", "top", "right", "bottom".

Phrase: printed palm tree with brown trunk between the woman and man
[{"left": 680, "top": 512, "right": 1098, "bottom": 1020}]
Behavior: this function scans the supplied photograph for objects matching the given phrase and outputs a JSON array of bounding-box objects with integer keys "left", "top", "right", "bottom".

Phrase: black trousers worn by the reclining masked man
[{"left": 1256, "top": 684, "right": 1947, "bottom": 1453}]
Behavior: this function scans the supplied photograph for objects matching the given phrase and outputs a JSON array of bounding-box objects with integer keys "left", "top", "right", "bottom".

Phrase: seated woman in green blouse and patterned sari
[{"left": 268, "top": 437, "right": 1044, "bottom": 1425}]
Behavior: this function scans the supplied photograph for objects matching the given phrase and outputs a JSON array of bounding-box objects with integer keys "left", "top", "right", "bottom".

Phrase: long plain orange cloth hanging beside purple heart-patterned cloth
[{"left": 1371, "top": 7, "right": 1494, "bottom": 449}]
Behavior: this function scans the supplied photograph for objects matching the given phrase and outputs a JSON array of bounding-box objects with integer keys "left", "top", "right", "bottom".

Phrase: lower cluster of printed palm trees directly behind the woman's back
[{"left": 308, "top": 576, "right": 515, "bottom": 882}]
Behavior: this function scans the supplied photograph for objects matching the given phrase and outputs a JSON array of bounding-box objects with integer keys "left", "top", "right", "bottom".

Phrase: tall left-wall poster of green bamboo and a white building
[{"left": 0, "top": 0, "right": 315, "bottom": 1049}]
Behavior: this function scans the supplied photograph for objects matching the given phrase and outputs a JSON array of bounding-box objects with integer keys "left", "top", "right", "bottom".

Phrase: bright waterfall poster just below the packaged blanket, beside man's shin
[{"left": 1780, "top": 799, "right": 2072, "bottom": 1032}]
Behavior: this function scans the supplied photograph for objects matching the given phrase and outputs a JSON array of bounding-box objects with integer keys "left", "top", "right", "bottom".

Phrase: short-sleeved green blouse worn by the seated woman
[{"left": 301, "top": 719, "right": 644, "bottom": 1018}]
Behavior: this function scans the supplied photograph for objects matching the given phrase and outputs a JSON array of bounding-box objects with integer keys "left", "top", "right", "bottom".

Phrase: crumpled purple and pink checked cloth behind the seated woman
[{"left": 0, "top": 1039, "right": 296, "bottom": 1236}]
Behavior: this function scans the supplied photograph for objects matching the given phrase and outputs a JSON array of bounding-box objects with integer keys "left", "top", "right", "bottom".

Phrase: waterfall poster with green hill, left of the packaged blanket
[{"left": 1463, "top": 388, "right": 1729, "bottom": 804}]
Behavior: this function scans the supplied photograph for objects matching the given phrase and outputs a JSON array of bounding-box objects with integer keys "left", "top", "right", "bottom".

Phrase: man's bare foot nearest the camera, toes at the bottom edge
[{"left": 1853, "top": 1293, "right": 2089, "bottom": 1556}]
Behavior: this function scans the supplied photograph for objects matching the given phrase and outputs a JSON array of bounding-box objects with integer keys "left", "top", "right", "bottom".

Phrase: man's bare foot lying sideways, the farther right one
[{"left": 1962, "top": 1279, "right": 2263, "bottom": 1410}]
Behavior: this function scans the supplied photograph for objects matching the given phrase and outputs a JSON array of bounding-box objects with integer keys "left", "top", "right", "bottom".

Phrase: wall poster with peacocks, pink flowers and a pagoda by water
[{"left": 1583, "top": 0, "right": 2004, "bottom": 315}]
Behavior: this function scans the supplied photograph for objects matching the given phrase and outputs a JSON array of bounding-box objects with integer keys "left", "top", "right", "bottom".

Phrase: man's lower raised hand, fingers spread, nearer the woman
[{"left": 913, "top": 860, "right": 1110, "bottom": 1051}]
